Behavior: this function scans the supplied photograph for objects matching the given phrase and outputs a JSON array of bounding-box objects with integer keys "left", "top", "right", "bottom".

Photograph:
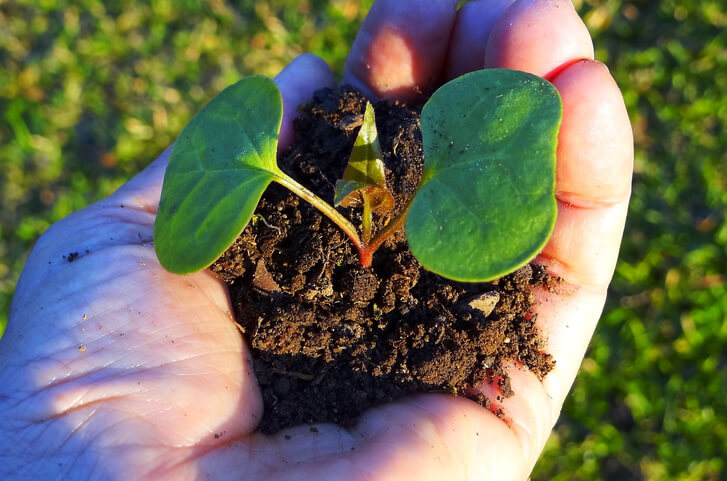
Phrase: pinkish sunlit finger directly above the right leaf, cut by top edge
[{"left": 485, "top": 0, "right": 593, "bottom": 77}]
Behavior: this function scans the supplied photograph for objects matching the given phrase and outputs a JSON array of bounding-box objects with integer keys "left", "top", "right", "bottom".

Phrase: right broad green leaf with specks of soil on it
[{"left": 406, "top": 69, "right": 562, "bottom": 282}]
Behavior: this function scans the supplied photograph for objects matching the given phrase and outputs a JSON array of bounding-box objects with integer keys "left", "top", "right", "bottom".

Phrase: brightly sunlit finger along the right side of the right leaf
[{"left": 537, "top": 60, "right": 633, "bottom": 407}]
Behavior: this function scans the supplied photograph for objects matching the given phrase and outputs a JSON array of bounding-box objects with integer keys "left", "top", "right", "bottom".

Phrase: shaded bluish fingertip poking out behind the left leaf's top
[{"left": 274, "top": 53, "right": 336, "bottom": 154}]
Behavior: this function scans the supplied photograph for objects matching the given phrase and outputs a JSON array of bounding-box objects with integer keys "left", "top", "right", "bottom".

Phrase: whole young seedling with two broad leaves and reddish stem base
[{"left": 155, "top": 69, "right": 562, "bottom": 282}]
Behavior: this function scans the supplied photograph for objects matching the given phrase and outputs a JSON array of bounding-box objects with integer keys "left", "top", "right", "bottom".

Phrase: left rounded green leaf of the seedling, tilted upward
[{"left": 154, "top": 76, "right": 285, "bottom": 274}]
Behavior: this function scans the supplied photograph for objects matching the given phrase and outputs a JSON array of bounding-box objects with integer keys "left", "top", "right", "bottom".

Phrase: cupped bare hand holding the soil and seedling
[{"left": 0, "top": 0, "right": 633, "bottom": 480}]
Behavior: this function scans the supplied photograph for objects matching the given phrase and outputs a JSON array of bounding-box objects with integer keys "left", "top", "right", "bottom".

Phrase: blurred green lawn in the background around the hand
[{"left": 0, "top": 0, "right": 727, "bottom": 481}]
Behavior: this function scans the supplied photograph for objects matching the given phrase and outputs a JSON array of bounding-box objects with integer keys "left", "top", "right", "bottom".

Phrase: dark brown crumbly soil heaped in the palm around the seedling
[{"left": 212, "top": 86, "right": 558, "bottom": 433}]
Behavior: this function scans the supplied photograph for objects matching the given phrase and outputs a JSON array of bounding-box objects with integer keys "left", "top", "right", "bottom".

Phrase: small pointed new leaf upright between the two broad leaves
[{"left": 334, "top": 102, "right": 394, "bottom": 215}]
